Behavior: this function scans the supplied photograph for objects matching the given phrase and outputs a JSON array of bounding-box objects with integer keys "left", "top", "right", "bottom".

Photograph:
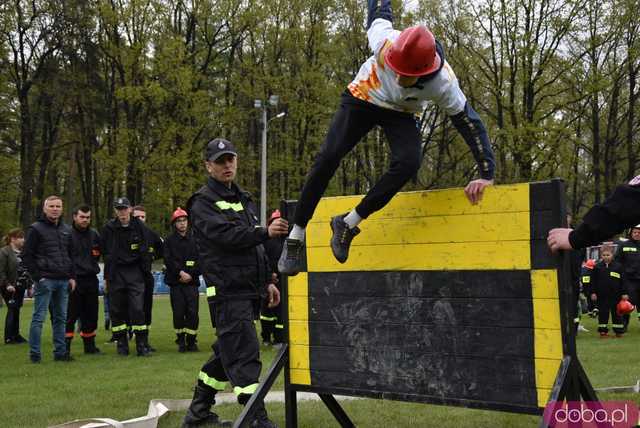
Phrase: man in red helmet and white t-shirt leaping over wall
[{"left": 278, "top": 0, "right": 495, "bottom": 275}]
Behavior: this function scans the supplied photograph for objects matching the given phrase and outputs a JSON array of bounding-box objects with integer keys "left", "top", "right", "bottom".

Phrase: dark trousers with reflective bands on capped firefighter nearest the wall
[{"left": 198, "top": 300, "right": 262, "bottom": 404}]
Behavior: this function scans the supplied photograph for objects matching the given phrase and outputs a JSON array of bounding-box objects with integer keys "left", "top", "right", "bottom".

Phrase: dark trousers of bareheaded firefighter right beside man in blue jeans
[{"left": 65, "top": 275, "right": 99, "bottom": 337}]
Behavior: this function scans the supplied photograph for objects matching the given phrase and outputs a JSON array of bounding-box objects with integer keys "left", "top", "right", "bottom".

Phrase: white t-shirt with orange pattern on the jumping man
[{"left": 348, "top": 18, "right": 467, "bottom": 116}]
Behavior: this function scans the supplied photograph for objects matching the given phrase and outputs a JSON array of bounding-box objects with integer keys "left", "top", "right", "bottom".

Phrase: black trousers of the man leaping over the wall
[{"left": 295, "top": 94, "right": 422, "bottom": 227}]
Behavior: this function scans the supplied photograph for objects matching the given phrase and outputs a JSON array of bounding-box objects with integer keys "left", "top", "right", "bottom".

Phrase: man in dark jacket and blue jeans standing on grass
[{"left": 23, "top": 196, "right": 76, "bottom": 363}]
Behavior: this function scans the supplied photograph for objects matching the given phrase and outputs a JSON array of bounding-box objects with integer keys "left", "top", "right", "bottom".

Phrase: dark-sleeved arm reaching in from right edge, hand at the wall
[{"left": 547, "top": 175, "right": 640, "bottom": 251}]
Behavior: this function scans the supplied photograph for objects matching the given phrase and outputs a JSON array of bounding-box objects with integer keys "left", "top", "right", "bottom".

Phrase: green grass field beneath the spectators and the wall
[{"left": 0, "top": 296, "right": 640, "bottom": 428}]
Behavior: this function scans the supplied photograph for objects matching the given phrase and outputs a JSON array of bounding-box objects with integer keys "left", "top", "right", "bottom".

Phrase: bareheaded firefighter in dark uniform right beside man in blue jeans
[{"left": 65, "top": 205, "right": 100, "bottom": 354}]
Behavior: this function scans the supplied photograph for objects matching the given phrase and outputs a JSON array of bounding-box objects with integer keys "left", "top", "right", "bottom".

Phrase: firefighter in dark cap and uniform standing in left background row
[{"left": 101, "top": 198, "right": 150, "bottom": 356}]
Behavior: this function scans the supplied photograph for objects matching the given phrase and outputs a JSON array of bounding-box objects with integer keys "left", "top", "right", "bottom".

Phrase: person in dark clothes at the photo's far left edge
[{"left": 0, "top": 229, "right": 33, "bottom": 345}]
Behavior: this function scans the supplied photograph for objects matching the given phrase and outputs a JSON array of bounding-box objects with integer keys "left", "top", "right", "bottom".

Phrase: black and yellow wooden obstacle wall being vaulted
[{"left": 286, "top": 180, "right": 575, "bottom": 413}]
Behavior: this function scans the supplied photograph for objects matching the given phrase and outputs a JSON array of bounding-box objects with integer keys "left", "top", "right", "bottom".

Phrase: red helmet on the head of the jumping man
[{"left": 384, "top": 25, "right": 441, "bottom": 77}]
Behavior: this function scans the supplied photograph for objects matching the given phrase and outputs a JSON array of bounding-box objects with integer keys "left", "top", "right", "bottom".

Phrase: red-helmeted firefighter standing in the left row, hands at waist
[{"left": 164, "top": 207, "right": 200, "bottom": 352}]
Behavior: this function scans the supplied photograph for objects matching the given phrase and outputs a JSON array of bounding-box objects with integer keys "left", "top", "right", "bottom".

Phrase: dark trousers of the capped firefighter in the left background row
[{"left": 109, "top": 265, "right": 147, "bottom": 334}]
